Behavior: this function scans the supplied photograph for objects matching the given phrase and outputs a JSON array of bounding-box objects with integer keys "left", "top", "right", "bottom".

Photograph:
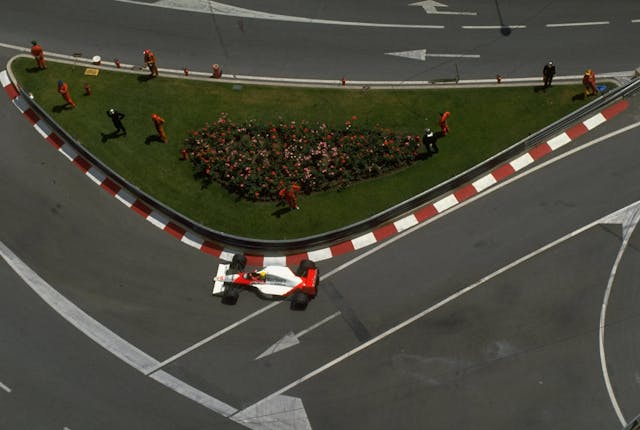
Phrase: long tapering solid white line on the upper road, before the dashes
[{"left": 114, "top": 0, "right": 444, "bottom": 29}]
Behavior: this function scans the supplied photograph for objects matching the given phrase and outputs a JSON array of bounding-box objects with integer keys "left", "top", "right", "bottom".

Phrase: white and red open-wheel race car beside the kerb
[{"left": 212, "top": 254, "right": 320, "bottom": 309}]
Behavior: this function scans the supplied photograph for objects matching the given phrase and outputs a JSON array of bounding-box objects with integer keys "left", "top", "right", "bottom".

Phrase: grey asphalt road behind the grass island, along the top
[{"left": 0, "top": 0, "right": 640, "bottom": 81}]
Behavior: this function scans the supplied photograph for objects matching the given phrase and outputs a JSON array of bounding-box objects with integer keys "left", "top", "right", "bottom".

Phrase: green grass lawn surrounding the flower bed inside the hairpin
[{"left": 12, "top": 54, "right": 596, "bottom": 239}]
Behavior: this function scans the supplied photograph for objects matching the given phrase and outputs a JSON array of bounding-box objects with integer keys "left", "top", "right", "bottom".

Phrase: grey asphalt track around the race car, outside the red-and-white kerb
[{"left": 0, "top": 3, "right": 640, "bottom": 430}]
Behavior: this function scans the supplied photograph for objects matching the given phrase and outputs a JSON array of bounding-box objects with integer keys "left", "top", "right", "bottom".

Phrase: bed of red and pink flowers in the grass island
[{"left": 182, "top": 113, "right": 421, "bottom": 200}]
